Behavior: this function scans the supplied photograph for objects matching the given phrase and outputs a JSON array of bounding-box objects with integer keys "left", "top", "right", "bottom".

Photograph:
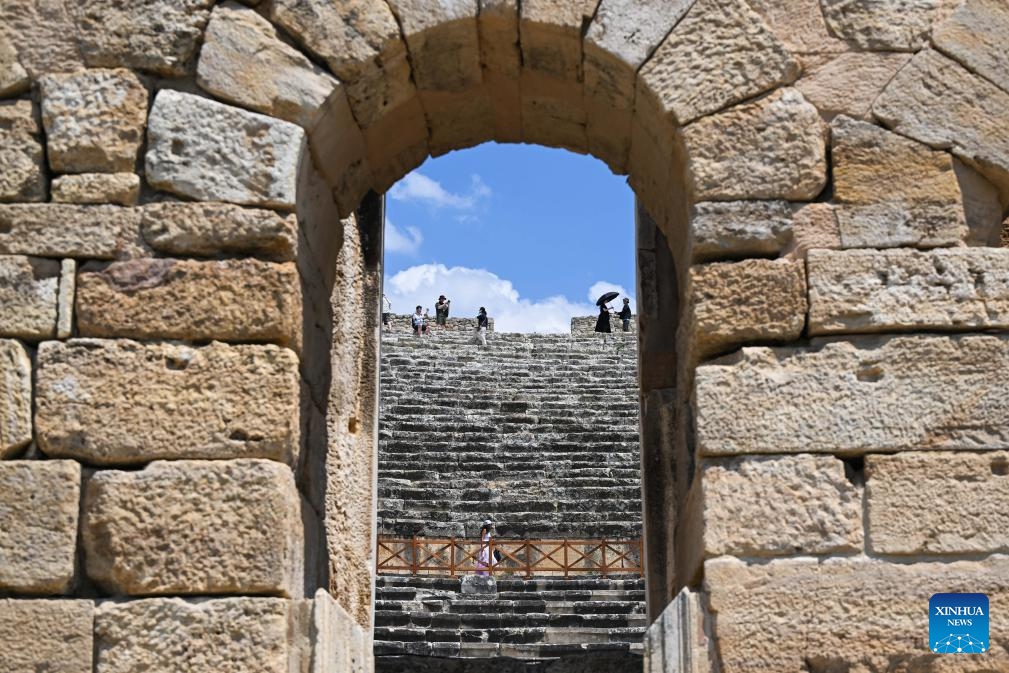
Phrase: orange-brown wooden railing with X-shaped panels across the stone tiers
[{"left": 376, "top": 537, "right": 642, "bottom": 577}]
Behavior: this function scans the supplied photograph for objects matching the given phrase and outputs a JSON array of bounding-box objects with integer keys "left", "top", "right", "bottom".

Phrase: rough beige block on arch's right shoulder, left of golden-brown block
[{"left": 683, "top": 89, "right": 826, "bottom": 201}]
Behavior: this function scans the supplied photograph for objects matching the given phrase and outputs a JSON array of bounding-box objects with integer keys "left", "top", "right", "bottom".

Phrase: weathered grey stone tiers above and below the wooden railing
[{"left": 375, "top": 321, "right": 647, "bottom": 673}]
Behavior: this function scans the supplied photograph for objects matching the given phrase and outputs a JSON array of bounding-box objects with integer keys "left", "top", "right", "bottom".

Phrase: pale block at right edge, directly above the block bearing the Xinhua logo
[{"left": 866, "top": 451, "right": 1009, "bottom": 554}]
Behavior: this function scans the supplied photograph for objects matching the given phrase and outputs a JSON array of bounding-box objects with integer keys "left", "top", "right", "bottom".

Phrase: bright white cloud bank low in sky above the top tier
[{"left": 384, "top": 264, "right": 619, "bottom": 333}]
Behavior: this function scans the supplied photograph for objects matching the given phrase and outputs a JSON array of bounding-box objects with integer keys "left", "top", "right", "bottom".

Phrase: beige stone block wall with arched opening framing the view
[{"left": 0, "top": 0, "right": 1009, "bottom": 673}]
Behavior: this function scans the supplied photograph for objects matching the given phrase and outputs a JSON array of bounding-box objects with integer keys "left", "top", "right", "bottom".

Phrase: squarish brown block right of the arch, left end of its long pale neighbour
[{"left": 688, "top": 259, "right": 806, "bottom": 357}]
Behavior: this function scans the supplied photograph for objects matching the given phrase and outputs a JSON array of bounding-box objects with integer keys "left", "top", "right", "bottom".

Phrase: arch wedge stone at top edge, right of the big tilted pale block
[{"left": 269, "top": 0, "right": 417, "bottom": 128}]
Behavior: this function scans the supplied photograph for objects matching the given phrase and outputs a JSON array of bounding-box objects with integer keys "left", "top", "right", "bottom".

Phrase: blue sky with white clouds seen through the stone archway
[{"left": 385, "top": 143, "right": 635, "bottom": 332}]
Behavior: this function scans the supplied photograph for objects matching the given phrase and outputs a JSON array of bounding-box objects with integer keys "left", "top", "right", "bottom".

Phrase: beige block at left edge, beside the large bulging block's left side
[{"left": 0, "top": 460, "right": 81, "bottom": 593}]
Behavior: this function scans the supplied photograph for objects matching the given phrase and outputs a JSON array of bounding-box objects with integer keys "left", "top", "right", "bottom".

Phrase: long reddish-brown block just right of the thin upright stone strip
[{"left": 77, "top": 258, "right": 302, "bottom": 345}]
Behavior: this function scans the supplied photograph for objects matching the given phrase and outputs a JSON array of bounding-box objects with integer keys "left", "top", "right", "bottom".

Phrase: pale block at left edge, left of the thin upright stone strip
[{"left": 0, "top": 255, "right": 60, "bottom": 339}]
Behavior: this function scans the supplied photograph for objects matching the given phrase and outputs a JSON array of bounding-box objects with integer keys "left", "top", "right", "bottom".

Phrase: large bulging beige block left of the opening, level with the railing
[{"left": 82, "top": 459, "right": 304, "bottom": 595}]
